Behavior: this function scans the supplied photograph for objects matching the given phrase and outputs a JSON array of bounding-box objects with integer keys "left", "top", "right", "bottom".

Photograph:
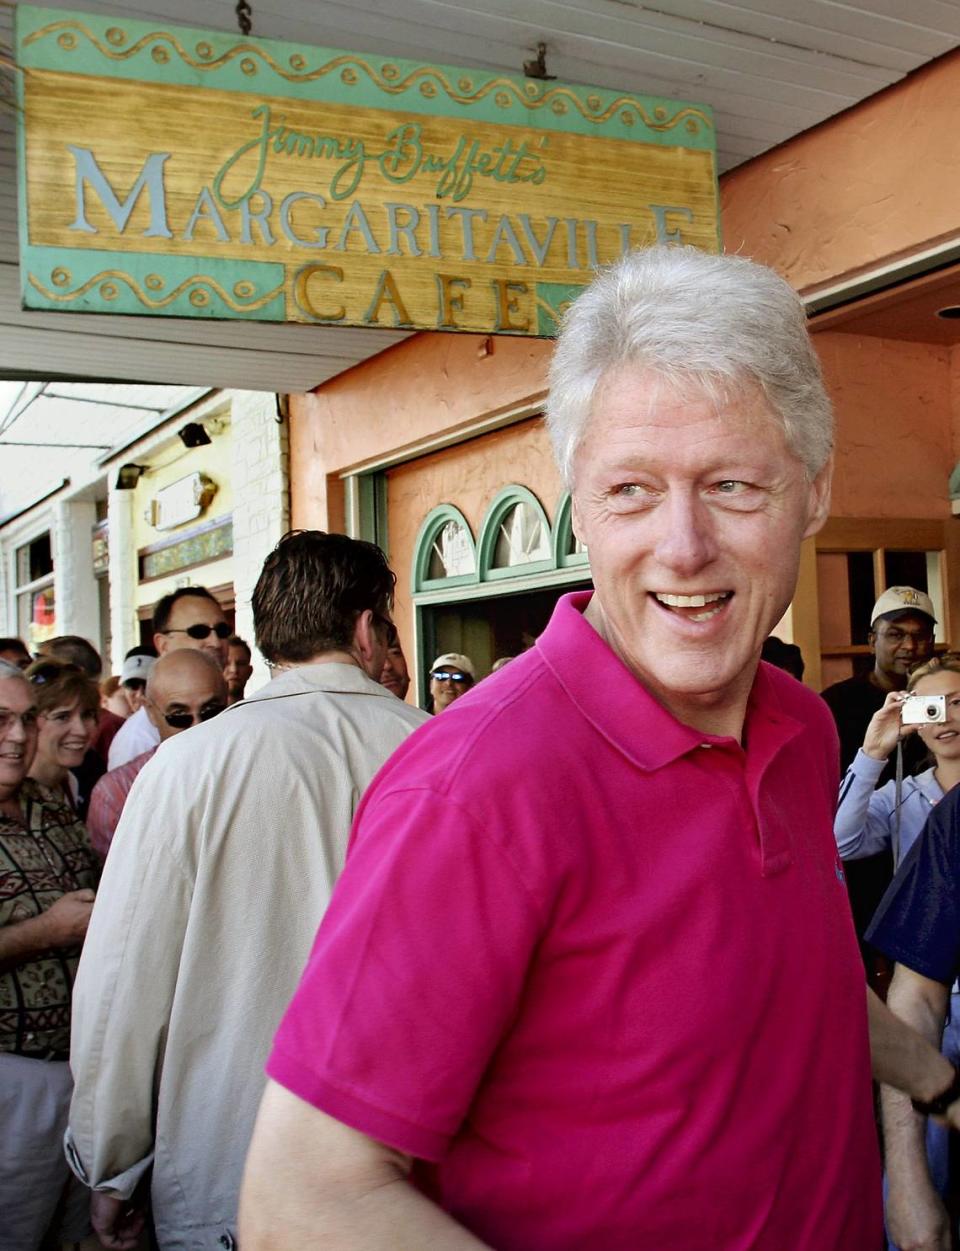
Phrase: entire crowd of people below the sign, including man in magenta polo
[{"left": 0, "top": 246, "right": 960, "bottom": 1251}]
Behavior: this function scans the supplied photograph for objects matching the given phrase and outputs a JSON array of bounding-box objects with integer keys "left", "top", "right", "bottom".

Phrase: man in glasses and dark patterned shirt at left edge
[{"left": 0, "top": 661, "right": 98, "bottom": 1251}]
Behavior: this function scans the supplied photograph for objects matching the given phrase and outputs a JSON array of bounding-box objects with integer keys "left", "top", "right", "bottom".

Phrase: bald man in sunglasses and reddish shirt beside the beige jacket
[{"left": 86, "top": 648, "right": 229, "bottom": 859}]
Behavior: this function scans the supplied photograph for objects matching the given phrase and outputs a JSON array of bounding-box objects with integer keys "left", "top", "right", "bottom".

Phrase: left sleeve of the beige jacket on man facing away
[{"left": 65, "top": 766, "right": 193, "bottom": 1198}]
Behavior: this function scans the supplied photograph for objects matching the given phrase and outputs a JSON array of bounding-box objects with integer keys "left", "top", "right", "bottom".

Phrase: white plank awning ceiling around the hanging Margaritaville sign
[{"left": 0, "top": 0, "right": 960, "bottom": 392}]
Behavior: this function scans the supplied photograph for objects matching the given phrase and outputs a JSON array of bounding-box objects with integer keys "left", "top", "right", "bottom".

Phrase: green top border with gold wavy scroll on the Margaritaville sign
[{"left": 15, "top": 5, "right": 716, "bottom": 151}]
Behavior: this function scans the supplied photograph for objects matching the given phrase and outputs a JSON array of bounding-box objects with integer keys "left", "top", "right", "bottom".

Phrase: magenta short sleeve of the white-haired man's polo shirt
[{"left": 267, "top": 789, "right": 542, "bottom": 1161}]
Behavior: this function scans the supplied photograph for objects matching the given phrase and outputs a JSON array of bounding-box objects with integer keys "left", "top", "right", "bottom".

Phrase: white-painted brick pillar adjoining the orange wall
[{"left": 230, "top": 392, "right": 290, "bottom": 693}]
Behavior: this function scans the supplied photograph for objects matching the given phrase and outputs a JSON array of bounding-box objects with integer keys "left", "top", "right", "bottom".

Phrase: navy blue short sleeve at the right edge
[{"left": 866, "top": 792, "right": 960, "bottom": 986}]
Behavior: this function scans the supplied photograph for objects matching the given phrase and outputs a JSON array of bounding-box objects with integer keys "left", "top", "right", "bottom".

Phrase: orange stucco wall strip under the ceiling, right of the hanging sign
[{"left": 720, "top": 53, "right": 960, "bottom": 291}]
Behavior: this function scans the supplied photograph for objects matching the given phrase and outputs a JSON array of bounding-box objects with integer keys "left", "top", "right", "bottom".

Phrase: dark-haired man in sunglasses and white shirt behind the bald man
[{"left": 106, "top": 587, "right": 233, "bottom": 769}]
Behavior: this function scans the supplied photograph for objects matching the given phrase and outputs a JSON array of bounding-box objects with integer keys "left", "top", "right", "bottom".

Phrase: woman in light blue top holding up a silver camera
[{"left": 834, "top": 652, "right": 960, "bottom": 1251}]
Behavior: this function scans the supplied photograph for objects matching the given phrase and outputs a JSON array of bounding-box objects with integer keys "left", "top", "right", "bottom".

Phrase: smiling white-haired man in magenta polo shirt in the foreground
[{"left": 240, "top": 248, "right": 954, "bottom": 1251}]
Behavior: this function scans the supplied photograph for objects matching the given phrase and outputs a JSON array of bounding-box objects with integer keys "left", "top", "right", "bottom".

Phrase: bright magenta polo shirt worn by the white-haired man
[{"left": 268, "top": 595, "right": 881, "bottom": 1251}]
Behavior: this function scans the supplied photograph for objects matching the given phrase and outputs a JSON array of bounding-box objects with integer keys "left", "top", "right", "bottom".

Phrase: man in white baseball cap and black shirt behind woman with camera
[{"left": 822, "top": 587, "right": 936, "bottom": 973}]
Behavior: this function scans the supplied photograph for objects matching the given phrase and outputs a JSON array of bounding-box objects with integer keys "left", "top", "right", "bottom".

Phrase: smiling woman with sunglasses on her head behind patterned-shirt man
[{"left": 26, "top": 659, "right": 100, "bottom": 812}]
